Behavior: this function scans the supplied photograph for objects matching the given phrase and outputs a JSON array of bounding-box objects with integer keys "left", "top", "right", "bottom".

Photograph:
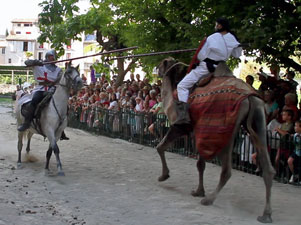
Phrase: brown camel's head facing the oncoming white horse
[{"left": 157, "top": 57, "right": 188, "bottom": 88}]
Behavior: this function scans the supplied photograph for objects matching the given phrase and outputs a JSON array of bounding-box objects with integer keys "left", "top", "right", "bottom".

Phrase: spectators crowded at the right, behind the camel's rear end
[{"left": 246, "top": 66, "right": 301, "bottom": 183}]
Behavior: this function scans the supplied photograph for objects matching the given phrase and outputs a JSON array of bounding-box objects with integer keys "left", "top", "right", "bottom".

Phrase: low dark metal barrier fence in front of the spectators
[{"left": 68, "top": 107, "right": 301, "bottom": 185}]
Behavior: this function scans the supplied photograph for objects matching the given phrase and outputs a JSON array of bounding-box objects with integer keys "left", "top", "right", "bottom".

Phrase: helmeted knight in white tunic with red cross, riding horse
[{"left": 18, "top": 50, "right": 62, "bottom": 131}]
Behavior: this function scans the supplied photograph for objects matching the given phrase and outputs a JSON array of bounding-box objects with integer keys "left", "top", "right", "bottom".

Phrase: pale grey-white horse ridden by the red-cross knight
[{"left": 16, "top": 63, "right": 83, "bottom": 176}]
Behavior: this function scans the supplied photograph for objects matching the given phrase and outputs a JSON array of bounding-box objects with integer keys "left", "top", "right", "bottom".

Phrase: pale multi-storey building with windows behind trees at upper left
[{"left": 0, "top": 19, "right": 97, "bottom": 75}]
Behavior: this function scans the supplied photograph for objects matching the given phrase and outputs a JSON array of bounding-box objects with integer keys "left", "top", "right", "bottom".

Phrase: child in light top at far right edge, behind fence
[{"left": 287, "top": 120, "right": 301, "bottom": 183}]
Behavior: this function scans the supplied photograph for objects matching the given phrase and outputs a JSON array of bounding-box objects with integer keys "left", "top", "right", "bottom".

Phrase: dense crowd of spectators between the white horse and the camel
[{"left": 69, "top": 73, "right": 163, "bottom": 141}]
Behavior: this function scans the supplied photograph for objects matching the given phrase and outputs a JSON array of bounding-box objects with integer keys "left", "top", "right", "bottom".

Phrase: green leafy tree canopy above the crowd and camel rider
[{"left": 39, "top": 0, "right": 301, "bottom": 81}]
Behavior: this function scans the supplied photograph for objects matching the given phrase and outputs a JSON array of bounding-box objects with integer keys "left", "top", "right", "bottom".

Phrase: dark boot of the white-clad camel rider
[{"left": 171, "top": 101, "right": 192, "bottom": 133}]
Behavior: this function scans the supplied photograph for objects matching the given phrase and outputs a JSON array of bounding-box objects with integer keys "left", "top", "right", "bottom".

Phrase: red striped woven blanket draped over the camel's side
[{"left": 189, "top": 77, "right": 257, "bottom": 160}]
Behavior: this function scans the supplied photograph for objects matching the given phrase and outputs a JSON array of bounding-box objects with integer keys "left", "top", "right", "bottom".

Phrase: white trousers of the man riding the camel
[{"left": 177, "top": 62, "right": 209, "bottom": 102}]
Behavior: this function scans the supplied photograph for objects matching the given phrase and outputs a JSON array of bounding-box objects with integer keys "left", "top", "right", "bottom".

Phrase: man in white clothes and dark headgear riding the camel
[{"left": 172, "top": 18, "right": 242, "bottom": 128}]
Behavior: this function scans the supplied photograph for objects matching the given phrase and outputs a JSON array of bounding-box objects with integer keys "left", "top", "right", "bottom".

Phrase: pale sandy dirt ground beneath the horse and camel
[{"left": 0, "top": 102, "right": 301, "bottom": 225}]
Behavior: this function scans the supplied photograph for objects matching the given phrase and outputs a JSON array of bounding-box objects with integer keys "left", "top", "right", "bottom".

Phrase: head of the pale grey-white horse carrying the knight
[{"left": 64, "top": 62, "right": 83, "bottom": 92}]
